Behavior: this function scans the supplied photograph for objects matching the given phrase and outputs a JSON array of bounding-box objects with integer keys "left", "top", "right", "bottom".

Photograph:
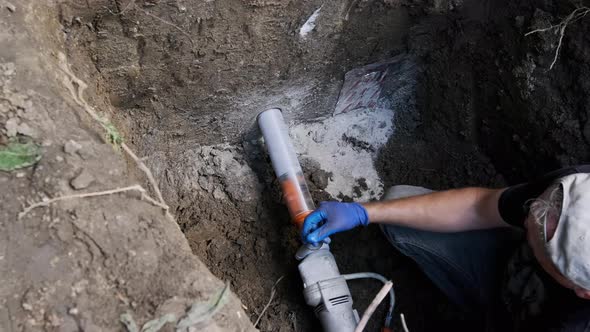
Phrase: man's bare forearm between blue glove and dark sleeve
[{"left": 363, "top": 187, "right": 508, "bottom": 232}]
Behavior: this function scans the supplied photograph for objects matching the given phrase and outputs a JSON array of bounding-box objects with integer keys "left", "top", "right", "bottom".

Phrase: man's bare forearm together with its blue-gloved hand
[{"left": 302, "top": 188, "right": 508, "bottom": 243}]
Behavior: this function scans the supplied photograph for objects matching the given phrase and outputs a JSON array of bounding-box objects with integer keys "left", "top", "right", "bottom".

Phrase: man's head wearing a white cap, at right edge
[{"left": 525, "top": 173, "right": 590, "bottom": 300}]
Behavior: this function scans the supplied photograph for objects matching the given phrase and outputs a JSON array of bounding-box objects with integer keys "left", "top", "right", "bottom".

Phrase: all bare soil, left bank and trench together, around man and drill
[{"left": 0, "top": 0, "right": 590, "bottom": 331}]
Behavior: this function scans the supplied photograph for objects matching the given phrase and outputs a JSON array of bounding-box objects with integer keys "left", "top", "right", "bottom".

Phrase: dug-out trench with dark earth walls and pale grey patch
[{"left": 60, "top": 0, "right": 590, "bottom": 331}]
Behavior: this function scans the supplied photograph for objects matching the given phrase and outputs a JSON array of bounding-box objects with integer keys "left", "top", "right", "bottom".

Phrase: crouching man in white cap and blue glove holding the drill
[{"left": 302, "top": 165, "right": 590, "bottom": 332}]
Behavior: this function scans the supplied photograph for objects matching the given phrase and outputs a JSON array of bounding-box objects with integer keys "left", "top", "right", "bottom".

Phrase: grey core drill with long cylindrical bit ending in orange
[{"left": 258, "top": 108, "right": 395, "bottom": 332}]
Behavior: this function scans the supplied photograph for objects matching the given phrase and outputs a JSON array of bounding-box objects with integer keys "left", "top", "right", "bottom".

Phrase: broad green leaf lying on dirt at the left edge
[{"left": 0, "top": 142, "right": 41, "bottom": 172}]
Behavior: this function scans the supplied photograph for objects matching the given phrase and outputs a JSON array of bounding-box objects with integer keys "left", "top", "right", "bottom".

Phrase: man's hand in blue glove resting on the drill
[{"left": 301, "top": 202, "right": 369, "bottom": 244}]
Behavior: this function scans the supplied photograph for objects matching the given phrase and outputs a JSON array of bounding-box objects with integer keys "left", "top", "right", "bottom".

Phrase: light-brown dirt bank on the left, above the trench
[{"left": 0, "top": 1, "right": 255, "bottom": 331}]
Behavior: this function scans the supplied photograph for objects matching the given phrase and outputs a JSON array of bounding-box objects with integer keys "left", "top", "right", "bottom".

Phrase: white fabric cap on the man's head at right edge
[{"left": 545, "top": 173, "right": 590, "bottom": 290}]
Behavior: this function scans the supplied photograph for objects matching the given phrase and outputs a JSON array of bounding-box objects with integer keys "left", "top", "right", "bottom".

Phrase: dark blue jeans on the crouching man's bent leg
[{"left": 381, "top": 186, "right": 523, "bottom": 312}]
